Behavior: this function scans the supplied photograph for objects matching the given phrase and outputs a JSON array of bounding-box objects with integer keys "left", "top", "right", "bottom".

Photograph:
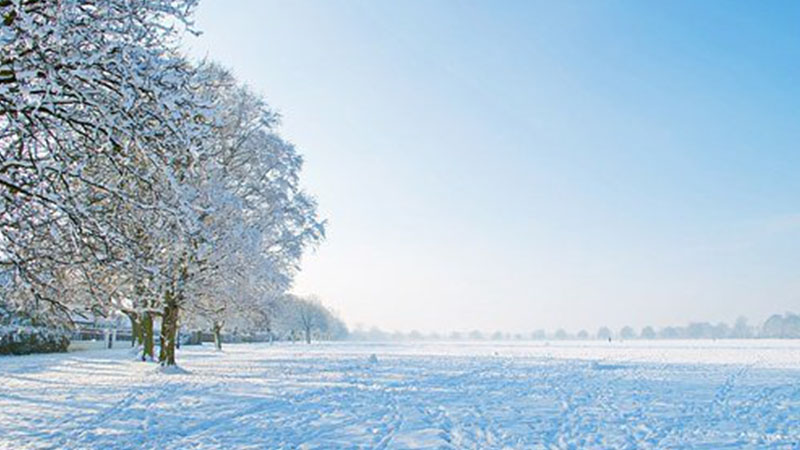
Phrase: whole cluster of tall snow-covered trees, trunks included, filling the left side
[{"left": 0, "top": 0, "right": 324, "bottom": 365}]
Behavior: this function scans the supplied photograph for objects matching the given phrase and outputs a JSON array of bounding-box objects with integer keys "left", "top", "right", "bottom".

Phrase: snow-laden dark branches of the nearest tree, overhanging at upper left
[{"left": 0, "top": 0, "right": 203, "bottom": 324}]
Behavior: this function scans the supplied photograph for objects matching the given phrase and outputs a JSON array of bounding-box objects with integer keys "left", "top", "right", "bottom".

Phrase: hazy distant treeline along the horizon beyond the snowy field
[{"left": 350, "top": 313, "right": 800, "bottom": 341}]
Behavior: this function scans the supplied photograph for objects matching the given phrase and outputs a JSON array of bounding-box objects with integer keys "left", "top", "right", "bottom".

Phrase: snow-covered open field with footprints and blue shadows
[{"left": 0, "top": 340, "right": 800, "bottom": 449}]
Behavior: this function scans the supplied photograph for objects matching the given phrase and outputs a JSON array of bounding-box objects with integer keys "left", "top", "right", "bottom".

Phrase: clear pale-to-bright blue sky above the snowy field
[{"left": 188, "top": 0, "right": 800, "bottom": 332}]
